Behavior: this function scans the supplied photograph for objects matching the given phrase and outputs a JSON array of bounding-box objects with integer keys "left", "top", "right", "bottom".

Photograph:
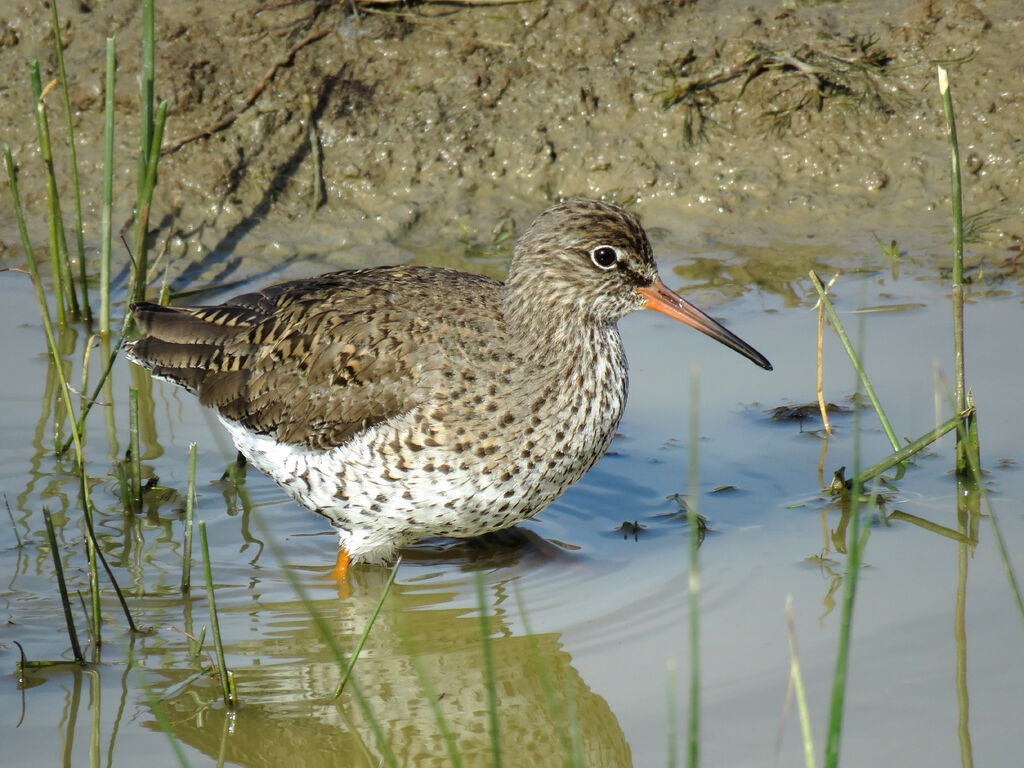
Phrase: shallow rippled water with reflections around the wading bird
[{"left": 0, "top": 226, "right": 1024, "bottom": 766}]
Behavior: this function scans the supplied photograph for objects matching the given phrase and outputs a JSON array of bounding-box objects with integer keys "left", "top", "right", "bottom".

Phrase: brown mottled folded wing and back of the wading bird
[{"left": 129, "top": 267, "right": 501, "bottom": 449}]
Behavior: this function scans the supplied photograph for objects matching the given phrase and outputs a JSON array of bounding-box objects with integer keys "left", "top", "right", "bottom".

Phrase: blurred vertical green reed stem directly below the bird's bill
[{"left": 686, "top": 366, "right": 700, "bottom": 768}]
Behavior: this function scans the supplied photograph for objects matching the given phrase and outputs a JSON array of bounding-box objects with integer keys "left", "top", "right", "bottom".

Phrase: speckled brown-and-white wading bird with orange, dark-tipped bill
[{"left": 128, "top": 200, "right": 771, "bottom": 575}]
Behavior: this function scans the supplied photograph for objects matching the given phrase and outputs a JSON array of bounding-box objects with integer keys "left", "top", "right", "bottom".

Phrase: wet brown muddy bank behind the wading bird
[{"left": 0, "top": 0, "right": 1024, "bottom": 282}]
